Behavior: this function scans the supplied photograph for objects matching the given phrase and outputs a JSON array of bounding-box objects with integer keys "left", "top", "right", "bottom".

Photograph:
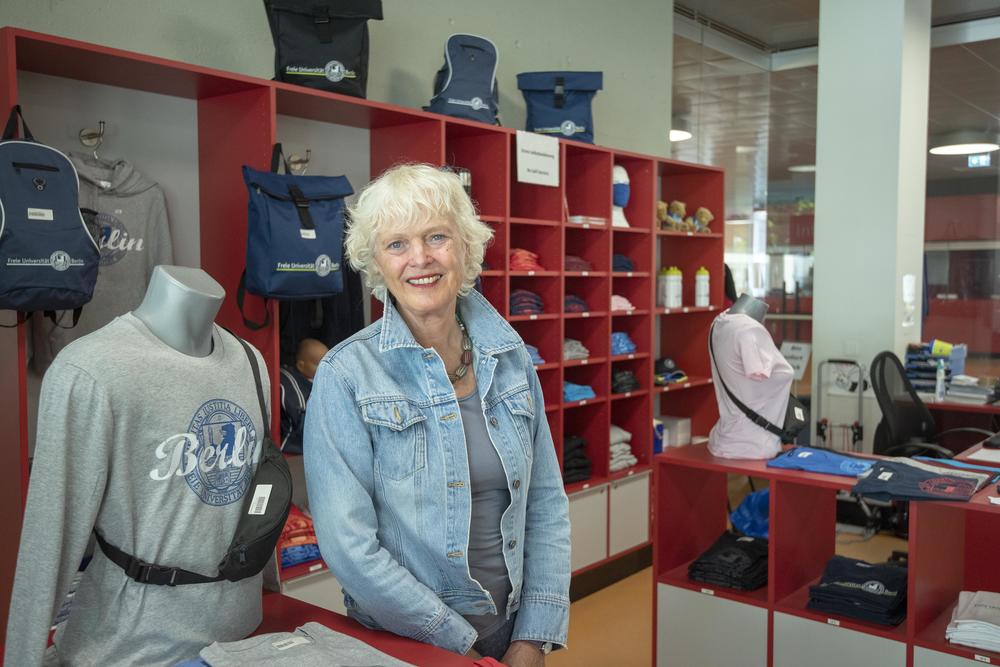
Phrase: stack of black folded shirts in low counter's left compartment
[{"left": 688, "top": 532, "right": 767, "bottom": 591}]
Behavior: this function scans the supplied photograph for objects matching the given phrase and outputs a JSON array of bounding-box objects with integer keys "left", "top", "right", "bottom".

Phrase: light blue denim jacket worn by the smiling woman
[{"left": 304, "top": 292, "right": 570, "bottom": 653}]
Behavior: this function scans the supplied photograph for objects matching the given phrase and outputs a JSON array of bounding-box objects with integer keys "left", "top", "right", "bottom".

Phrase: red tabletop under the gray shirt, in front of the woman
[{"left": 254, "top": 593, "right": 475, "bottom": 667}]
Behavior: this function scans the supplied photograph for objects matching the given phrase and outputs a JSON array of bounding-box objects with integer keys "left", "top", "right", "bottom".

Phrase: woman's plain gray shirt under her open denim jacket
[{"left": 458, "top": 391, "right": 511, "bottom": 639}]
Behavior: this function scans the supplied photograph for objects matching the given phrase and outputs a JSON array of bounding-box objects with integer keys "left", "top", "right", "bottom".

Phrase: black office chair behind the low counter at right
[{"left": 871, "top": 351, "right": 993, "bottom": 459}]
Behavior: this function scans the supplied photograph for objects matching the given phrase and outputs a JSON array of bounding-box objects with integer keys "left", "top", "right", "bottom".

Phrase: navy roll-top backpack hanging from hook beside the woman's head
[{"left": 236, "top": 144, "right": 354, "bottom": 329}]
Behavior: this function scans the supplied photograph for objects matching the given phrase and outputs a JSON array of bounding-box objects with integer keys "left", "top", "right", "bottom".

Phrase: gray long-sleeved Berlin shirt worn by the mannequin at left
[{"left": 4, "top": 313, "right": 270, "bottom": 667}]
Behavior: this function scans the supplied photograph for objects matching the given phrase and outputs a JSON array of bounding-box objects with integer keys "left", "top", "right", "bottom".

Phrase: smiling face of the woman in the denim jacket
[{"left": 375, "top": 218, "right": 464, "bottom": 318}]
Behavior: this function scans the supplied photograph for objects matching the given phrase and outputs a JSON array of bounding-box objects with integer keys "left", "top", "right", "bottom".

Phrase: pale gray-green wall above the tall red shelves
[{"left": 0, "top": 0, "right": 673, "bottom": 155}]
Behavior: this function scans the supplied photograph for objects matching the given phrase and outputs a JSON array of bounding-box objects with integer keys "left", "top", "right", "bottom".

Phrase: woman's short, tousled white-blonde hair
[{"left": 344, "top": 164, "right": 493, "bottom": 301}]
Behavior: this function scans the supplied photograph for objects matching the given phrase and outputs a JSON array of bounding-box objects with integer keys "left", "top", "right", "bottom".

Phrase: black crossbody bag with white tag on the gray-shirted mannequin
[{"left": 94, "top": 329, "right": 292, "bottom": 586}]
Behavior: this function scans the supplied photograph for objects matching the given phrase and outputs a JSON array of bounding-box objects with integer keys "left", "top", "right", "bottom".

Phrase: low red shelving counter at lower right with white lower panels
[{"left": 653, "top": 445, "right": 1000, "bottom": 667}]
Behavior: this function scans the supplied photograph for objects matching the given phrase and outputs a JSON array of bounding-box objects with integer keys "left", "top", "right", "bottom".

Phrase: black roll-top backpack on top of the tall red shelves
[{"left": 264, "top": 0, "right": 382, "bottom": 97}]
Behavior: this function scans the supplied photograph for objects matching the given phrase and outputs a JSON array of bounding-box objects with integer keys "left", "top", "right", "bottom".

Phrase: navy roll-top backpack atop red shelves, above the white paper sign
[{"left": 517, "top": 72, "right": 603, "bottom": 144}]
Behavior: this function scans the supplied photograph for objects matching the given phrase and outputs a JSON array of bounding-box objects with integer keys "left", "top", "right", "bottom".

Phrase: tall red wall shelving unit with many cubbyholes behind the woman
[{"left": 0, "top": 28, "right": 736, "bottom": 626}]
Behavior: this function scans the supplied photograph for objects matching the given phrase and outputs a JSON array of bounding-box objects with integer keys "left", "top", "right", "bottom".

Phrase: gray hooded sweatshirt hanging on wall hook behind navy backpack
[{"left": 32, "top": 153, "right": 174, "bottom": 374}]
